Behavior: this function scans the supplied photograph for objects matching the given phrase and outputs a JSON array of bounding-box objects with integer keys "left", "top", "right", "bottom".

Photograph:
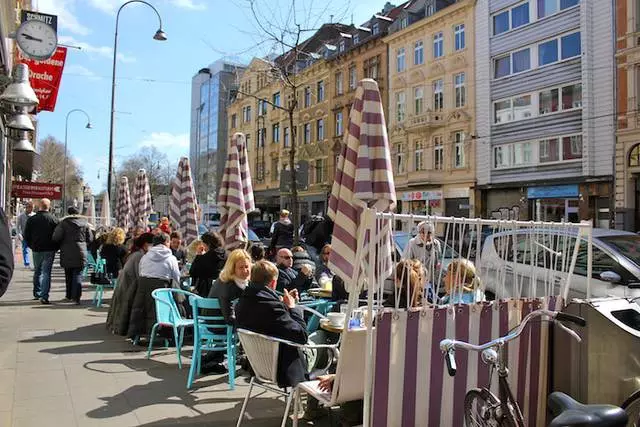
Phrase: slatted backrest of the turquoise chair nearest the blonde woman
[{"left": 189, "top": 295, "right": 233, "bottom": 343}]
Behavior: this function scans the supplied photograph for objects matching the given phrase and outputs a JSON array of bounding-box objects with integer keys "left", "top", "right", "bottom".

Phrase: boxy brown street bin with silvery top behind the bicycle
[{"left": 551, "top": 298, "right": 640, "bottom": 406}]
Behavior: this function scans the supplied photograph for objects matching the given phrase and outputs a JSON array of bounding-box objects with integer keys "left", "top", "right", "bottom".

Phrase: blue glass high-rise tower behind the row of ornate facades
[{"left": 189, "top": 60, "right": 245, "bottom": 212}]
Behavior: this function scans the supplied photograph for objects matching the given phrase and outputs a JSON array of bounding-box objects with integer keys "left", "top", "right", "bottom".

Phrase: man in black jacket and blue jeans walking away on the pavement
[{"left": 23, "top": 199, "right": 58, "bottom": 304}]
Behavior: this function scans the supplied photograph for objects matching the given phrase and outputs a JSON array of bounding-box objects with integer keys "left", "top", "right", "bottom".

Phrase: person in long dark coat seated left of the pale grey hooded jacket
[{"left": 107, "top": 233, "right": 153, "bottom": 336}]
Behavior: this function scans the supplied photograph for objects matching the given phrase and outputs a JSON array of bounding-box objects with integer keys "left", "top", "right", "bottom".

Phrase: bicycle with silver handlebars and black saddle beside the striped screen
[{"left": 440, "top": 310, "right": 627, "bottom": 427}]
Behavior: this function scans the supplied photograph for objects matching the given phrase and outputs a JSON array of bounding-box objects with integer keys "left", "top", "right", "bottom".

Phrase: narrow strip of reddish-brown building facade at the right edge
[{"left": 615, "top": 0, "right": 640, "bottom": 231}]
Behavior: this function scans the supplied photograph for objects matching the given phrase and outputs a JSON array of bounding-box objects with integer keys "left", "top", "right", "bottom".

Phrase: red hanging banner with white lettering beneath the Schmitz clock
[{"left": 18, "top": 46, "right": 67, "bottom": 111}]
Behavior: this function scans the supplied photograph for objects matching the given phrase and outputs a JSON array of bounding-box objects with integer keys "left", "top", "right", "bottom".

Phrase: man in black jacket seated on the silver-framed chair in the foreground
[{"left": 236, "top": 260, "right": 308, "bottom": 387}]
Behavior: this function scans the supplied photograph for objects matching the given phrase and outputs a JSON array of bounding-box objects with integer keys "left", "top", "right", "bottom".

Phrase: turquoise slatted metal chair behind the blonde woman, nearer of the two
[{"left": 187, "top": 295, "right": 236, "bottom": 390}]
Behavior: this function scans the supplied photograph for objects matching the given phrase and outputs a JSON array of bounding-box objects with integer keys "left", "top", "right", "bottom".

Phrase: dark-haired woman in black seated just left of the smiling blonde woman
[{"left": 189, "top": 231, "right": 227, "bottom": 297}]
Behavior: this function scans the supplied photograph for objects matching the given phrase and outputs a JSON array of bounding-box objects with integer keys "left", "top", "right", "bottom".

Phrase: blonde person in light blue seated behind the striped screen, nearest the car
[{"left": 440, "top": 258, "right": 485, "bottom": 304}]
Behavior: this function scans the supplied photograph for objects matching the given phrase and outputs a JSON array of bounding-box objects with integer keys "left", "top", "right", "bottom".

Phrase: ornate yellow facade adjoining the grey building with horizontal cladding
[{"left": 384, "top": 0, "right": 476, "bottom": 217}]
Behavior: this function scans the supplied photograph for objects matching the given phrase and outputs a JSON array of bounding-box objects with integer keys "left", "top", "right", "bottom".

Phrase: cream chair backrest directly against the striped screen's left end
[{"left": 331, "top": 329, "right": 367, "bottom": 405}]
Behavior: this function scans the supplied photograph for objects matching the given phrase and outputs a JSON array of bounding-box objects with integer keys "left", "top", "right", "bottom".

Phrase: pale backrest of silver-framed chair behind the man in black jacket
[{"left": 238, "top": 329, "right": 280, "bottom": 384}]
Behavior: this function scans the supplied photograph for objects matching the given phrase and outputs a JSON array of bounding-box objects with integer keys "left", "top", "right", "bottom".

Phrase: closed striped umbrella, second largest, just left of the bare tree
[{"left": 218, "top": 132, "right": 256, "bottom": 250}]
